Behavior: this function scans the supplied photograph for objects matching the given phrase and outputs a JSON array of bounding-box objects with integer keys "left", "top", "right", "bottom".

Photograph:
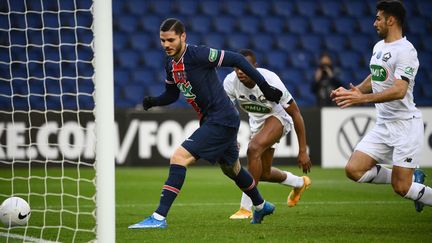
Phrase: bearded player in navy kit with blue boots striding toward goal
[{"left": 129, "top": 18, "right": 282, "bottom": 229}]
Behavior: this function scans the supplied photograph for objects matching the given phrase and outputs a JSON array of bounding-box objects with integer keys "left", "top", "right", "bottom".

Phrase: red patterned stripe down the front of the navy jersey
[{"left": 172, "top": 58, "right": 202, "bottom": 120}]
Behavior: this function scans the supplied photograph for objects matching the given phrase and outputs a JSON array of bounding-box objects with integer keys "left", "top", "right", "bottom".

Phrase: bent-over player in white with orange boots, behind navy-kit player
[{"left": 224, "top": 49, "right": 312, "bottom": 219}]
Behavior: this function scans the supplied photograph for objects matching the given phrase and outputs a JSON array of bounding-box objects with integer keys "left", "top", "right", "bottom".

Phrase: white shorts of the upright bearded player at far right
[{"left": 355, "top": 118, "right": 424, "bottom": 168}]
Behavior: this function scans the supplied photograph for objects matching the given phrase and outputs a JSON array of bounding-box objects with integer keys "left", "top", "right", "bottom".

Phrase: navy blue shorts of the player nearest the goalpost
[{"left": 182, "top": 123, "right": 239, "bottom": 165}]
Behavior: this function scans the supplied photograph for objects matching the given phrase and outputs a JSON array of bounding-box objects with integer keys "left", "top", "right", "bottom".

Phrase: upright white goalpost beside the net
[{"left": 93, "top": 0, "right": 115, "bottom": 243}]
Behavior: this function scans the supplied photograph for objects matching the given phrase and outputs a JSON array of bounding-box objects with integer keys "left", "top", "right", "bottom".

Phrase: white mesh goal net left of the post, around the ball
[{"left": 0, "top": 0, "right": 115, "bottom": 242}]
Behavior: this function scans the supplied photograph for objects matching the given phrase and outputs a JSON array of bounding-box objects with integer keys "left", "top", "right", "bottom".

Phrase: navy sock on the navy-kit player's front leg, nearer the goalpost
[{"left": 155, "top": 164, "right": 186, "bottom": 217}]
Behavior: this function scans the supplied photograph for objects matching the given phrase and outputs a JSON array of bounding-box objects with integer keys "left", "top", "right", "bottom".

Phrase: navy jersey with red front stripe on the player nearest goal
[{"left": 165, "top": 45, "right": 240, "bottom": 128}]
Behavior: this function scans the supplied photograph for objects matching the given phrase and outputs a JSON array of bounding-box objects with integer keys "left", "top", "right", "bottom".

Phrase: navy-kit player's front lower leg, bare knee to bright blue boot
[{"left": 129, "top": 146, "right": 195, "bottom": 229}]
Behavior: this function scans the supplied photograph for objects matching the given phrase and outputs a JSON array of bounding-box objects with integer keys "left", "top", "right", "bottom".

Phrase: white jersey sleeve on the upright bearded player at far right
[{"left": 394, "top": 48, "right": 419, "bottom": 82}]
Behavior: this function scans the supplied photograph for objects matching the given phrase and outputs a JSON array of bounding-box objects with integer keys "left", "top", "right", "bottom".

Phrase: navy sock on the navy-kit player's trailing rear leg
[{"left": 232, "top": 167, "right": 264, "bottom": 206}]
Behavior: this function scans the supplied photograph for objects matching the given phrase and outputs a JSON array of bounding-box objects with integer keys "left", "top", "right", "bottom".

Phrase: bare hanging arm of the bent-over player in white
[{"left": 284, "top": 99, "right": 312, "bottom": 173}]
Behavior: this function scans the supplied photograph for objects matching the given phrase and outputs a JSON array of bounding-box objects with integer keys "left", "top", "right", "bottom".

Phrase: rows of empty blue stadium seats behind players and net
[{"left": 0, "top": 0, "right": 432, "bottom": 109}]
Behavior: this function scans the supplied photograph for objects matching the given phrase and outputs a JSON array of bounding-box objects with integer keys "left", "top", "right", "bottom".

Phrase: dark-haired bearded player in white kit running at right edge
[{"left": 330, "top": 1, "right": 432, "bottom": 212}]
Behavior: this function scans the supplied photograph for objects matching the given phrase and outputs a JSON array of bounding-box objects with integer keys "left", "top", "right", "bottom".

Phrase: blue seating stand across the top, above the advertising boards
[{"left": 0, "top": 0, "right": 432, "bottom": 108}]
